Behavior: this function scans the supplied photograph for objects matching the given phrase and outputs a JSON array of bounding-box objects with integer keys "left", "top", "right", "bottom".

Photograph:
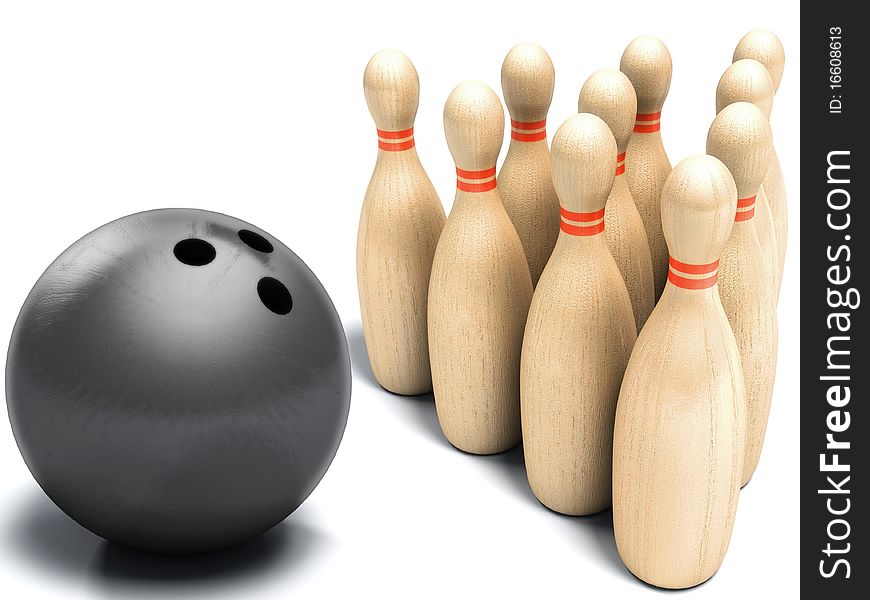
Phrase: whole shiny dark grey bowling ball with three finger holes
[{"left": 6, "top": 209, "right": 351, "bottom": 553}]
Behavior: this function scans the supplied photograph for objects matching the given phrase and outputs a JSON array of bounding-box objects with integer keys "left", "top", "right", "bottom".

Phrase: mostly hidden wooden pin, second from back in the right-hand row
[{"left": 716, "top": 58, "right": 785, "bottom": 299}]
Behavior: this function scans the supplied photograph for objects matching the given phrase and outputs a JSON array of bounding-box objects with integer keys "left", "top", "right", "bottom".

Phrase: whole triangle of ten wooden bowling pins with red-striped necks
[{"left": 357, "top": 30, "right": 787, "bottom": 588}]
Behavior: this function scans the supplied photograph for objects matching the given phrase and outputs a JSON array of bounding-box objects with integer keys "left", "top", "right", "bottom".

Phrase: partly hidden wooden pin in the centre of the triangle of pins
[{"left": 578, "top": 69, "right": 655, "bottom": 331}]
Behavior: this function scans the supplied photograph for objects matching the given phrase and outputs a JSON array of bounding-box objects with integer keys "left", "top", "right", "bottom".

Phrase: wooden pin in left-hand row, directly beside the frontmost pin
[{"left": 520, "top": 113, "right": 637, "bottom": 515}]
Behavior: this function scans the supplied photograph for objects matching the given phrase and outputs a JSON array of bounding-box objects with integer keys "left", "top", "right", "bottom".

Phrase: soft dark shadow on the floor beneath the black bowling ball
[{"left": 3, "top": 490, "right": 324, "bottom": 596}]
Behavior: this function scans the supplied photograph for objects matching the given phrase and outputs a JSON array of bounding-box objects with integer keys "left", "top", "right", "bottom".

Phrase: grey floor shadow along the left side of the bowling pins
[{"left": 346, "top": 322, "right": 640, "bottom": 589}]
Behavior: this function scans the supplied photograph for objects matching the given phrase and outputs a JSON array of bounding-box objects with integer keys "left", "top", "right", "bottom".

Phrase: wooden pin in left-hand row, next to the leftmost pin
[{"left": 429, "top": 81, "right": 532, "bottom": 454}]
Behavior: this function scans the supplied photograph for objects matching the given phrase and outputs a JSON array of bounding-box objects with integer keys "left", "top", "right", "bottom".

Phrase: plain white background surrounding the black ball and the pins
[{"left": 0, "top": 0, "right": 800, "bottom": 599}]
